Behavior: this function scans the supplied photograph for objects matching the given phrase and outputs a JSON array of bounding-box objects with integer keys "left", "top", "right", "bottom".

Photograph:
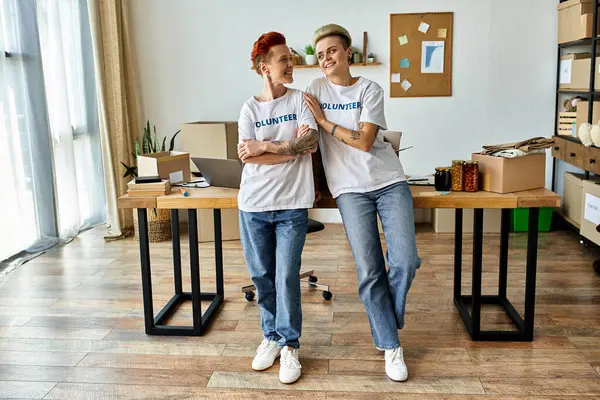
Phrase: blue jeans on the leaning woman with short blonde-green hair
[{"left": 336, "top": 182, "right": 421, "bottom": 349}]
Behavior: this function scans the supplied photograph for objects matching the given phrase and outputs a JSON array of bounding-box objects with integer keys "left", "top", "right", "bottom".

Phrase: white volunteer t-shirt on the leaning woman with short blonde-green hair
[{"left": 307, "top": 77, "right": 406, "bottom": 198}]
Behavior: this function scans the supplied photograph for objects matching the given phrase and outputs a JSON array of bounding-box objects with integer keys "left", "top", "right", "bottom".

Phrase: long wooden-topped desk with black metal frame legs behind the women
[{"left": 119, "top": 186, "right": 560, "bottom": 341}]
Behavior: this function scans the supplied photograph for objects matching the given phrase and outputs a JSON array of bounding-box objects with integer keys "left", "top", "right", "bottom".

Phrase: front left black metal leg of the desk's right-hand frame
[{"left": 471, "top": 208, "right": 483, "bottom": 340}]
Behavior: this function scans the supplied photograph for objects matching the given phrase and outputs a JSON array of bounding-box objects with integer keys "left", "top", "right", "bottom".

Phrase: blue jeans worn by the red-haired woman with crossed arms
[{"left": 240, "top": 209, "right": 308, "bottom": 348}]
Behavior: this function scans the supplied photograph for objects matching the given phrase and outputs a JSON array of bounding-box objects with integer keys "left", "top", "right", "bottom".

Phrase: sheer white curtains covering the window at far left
[{"left": 0, "top": 0, "right": 106, "bottom": 276}]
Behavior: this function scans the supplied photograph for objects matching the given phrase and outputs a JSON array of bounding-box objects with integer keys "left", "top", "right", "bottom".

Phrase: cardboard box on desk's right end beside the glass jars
[{"left": 472, "top": 153, "right": 546, "bottom": 193}]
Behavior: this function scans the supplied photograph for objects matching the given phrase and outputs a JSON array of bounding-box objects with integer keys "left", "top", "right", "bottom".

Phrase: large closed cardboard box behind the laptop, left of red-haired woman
[{"left": 179, "top": 121, "right": 238, "bottom": 172}]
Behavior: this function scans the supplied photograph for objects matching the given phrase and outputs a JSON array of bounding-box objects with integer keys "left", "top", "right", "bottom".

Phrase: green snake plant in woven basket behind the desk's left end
[{"left": 121, "top": 121, "right": 181, "bottom": 243}]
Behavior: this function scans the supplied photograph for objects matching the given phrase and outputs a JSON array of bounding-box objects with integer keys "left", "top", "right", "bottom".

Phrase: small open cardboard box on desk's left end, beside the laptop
[{"left": 137, "top": 151, "right": 192, "bottom": 184}]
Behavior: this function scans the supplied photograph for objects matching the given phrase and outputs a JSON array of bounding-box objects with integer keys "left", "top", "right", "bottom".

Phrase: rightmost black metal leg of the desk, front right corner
[{"left": 524, "top": 208, "right": 540, "bottom": 340}]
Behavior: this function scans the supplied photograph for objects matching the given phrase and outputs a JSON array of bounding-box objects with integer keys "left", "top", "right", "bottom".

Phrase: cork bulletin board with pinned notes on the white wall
[{"left": 389, "top": 12, "right": 454, "bottom": 97}]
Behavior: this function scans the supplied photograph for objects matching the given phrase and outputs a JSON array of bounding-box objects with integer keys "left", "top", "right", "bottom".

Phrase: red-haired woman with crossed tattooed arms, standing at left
[{"left": 238, "top": 32, "right": 318, "bottom": 383}]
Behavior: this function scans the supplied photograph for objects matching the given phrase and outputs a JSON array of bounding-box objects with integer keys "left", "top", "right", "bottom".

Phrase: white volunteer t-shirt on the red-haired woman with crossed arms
[{"left": 238, "top": 88, "right": 317, "bottom": 212}]
